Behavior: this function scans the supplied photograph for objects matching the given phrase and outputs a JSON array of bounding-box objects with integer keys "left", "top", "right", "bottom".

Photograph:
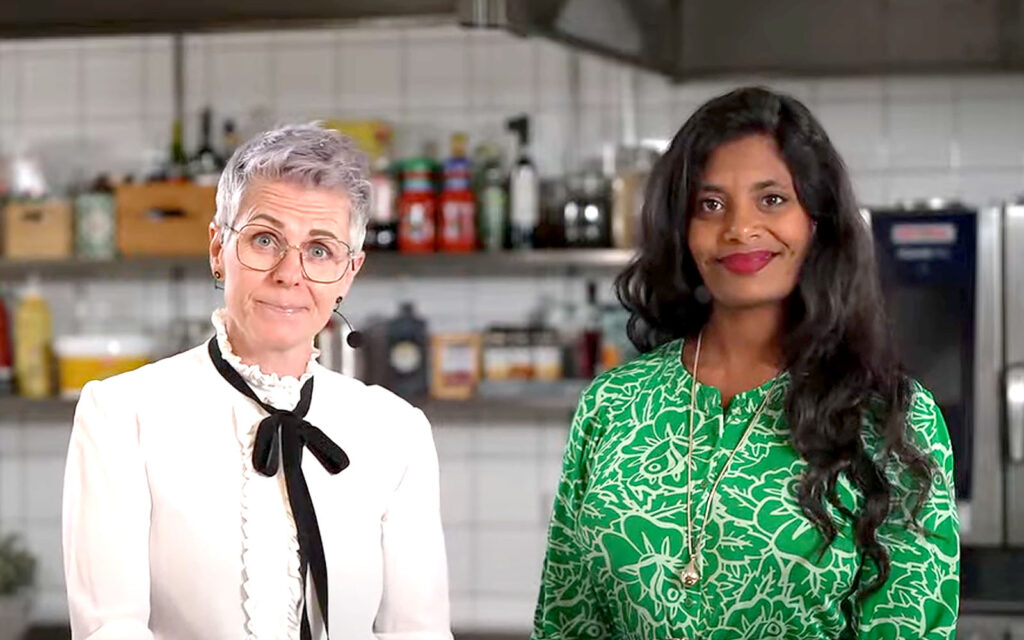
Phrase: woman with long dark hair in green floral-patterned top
[{"left": 534, "top": 88, "right": 959, "bottom": 640}]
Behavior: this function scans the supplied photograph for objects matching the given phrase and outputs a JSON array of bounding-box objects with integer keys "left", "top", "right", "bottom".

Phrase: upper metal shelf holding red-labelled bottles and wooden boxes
[{"left": 0, "top": 249, "right": 633, "bottom": 282}]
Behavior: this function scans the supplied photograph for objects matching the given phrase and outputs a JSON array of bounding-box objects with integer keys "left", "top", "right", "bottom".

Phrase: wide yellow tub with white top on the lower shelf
[{"left": 54, "top": 335, "right": 156, "bottom": 398}]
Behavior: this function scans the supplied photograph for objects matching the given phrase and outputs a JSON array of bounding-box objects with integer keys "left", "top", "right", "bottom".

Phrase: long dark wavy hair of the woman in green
[{"left": 615, "top": 87, "right": 935, "bottom": 596}]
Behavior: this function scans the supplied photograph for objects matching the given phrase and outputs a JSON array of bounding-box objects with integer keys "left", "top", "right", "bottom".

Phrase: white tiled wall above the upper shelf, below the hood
[{"left": 0, "top": 26, "right": 1024, "bottom": 198}]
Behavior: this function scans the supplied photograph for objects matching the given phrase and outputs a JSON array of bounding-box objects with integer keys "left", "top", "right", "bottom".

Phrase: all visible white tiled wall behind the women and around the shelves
[{"left": 0, "top": 17, "right": 1024, "bottom": 631}]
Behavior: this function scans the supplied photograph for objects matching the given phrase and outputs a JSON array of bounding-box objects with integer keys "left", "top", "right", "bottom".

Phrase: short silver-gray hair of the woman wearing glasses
[{"left": 213, "top": 124, "right": 373, "bottom": 251}]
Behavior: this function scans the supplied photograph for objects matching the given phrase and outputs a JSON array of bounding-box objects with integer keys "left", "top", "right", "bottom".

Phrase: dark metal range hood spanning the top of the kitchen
[{"left": 0, "top": 0, "right": 1024, "bottom": 81}]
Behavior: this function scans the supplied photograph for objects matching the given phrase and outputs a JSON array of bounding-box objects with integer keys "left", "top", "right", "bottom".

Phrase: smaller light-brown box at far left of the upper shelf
[{"left": 3, "top": 199, "right": 74, "bottom": 260}]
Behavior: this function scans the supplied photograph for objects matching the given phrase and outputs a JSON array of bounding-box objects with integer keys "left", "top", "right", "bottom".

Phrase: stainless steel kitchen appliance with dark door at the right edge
[{"left": 868, "top": 203, "right": 1024, "bottom": 548}]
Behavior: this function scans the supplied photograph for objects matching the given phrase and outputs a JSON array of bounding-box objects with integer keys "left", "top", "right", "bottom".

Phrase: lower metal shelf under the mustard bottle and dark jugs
[{"left": 0, "top": 396, "right": 575, "bottom": 427}]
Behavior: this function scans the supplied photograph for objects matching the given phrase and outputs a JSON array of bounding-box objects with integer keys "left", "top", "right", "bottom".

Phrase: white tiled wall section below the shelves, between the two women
[{"left": 434, "top": 423, "right": 567, "bottom": 631}]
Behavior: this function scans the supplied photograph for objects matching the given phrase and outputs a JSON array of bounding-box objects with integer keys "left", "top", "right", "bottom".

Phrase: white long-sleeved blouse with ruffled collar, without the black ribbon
[{"left": 63, "top": 312, "right": 452, "bottom": 640}]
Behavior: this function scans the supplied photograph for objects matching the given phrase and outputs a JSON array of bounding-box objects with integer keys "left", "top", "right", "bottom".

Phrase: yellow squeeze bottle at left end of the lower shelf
[{"left": 14, "top": 278, "right": 53, "bottom": 399}]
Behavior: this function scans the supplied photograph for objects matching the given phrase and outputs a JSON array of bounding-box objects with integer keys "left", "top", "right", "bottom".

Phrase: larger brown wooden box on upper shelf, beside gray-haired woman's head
[{"left": 116, "top": 182, "right": 217, "bottom": 256}]
